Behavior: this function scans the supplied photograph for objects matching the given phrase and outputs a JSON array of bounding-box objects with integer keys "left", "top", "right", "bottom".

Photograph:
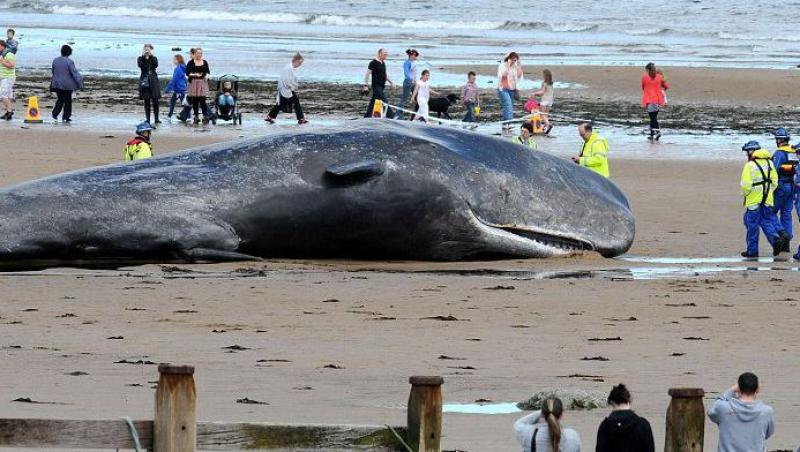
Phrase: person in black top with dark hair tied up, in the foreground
[{"left": 595, "top": 383, "right": 656, "bottom": 452}]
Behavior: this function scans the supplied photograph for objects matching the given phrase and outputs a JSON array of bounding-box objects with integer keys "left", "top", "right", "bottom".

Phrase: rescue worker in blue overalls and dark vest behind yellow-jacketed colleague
[{"left": 772, "top": 127, "right": 797, "bottom": 252}]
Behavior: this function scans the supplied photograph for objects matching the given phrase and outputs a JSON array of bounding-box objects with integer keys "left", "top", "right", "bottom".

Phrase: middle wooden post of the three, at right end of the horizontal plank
[{"left": 408, "top": 377, "right": 444, "bottom": 452}]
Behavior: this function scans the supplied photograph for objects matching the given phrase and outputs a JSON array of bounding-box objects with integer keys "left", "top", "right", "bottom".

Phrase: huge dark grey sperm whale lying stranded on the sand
[{"left": 0, "top": 119, "right": 634, "bottom": 268}]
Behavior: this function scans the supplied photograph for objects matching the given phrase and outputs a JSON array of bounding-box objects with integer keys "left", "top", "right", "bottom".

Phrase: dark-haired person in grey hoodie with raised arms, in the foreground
[{"left": 708, "top": 372, "right": 775, "bottom": 452}]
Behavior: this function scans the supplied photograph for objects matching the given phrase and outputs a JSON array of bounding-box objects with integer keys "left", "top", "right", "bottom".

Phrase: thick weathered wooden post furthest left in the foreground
[{"left": 153, "top": 364, "right": 197, "bottom": 452}]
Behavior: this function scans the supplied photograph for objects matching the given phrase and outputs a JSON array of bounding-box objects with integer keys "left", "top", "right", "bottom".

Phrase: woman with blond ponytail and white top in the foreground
[{"left": 514, "top": 397, "right": 581, "bottom": 452}]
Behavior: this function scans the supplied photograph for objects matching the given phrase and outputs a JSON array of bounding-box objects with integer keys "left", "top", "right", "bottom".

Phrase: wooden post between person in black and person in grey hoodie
[{"left": 664, "top": 388, "right": 706, "bottom": 452}]
